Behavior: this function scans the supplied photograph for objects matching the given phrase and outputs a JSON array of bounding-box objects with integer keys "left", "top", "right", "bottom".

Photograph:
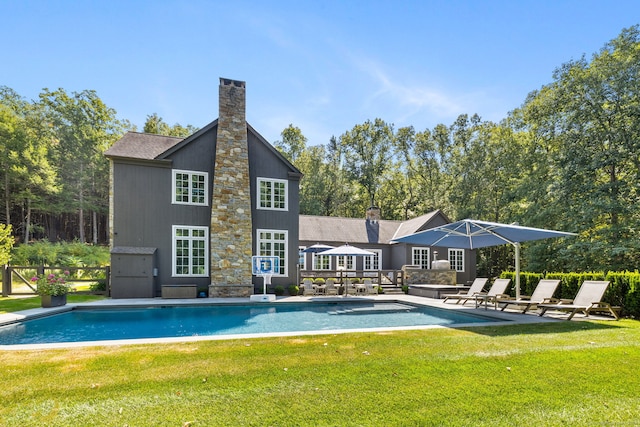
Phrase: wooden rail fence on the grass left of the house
[{"left": 2, "top": 265, "right": 111, "bottom": 297}]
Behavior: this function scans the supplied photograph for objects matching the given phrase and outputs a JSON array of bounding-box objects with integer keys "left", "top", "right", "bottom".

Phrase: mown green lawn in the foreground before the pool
[{"left": 0, "top": 314, "right": 640, "bottom": 426}]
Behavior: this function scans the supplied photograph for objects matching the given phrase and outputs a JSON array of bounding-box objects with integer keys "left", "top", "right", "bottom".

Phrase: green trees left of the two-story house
[{"left": 0, "top": 86, "right": 197, "bottom": 244}]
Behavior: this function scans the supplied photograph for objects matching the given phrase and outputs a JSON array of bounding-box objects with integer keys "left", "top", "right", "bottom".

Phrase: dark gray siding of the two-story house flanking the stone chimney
[{"left": 112, "top": 127, "right": 299, "bottom": 298}]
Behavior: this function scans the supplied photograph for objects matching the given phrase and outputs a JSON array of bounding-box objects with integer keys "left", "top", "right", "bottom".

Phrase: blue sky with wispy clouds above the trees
[{"left": 0, "top": 0, "right": 640, "bottom": 144}]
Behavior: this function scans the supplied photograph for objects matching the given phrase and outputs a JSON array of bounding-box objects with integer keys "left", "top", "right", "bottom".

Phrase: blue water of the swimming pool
[{"left": 0, "top": 302, "right": 495, "bottom": 345}]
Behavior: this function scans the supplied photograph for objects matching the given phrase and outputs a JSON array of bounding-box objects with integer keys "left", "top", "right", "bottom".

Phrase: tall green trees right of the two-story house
[{"left": 276, "top": 25, "right": 640, "bottom": 276}]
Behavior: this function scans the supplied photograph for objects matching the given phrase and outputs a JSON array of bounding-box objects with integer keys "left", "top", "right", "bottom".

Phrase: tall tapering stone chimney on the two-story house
[{"left": 209, "top": 78, "right": 253, "bottom": 297}]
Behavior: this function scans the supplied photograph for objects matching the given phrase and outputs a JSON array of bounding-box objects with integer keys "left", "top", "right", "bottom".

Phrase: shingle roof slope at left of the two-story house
[{"left": 104, "top": 132, "right": 184, "bottom": 160}]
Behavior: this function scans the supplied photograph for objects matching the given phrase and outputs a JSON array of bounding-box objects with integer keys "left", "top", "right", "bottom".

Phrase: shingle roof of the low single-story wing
[{"left": 299, "top": 210, "right": 440, "bottom": 244}]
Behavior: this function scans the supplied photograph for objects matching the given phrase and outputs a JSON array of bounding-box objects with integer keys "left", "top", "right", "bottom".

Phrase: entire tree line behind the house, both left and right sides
[{"left": 0, "top": 26, "right": 640, "bottom": 276}]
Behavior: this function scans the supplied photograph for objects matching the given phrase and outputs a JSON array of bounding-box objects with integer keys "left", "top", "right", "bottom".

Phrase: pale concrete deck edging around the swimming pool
[{"left": 0, "top": 295, "right": 612, "bottom": 350}]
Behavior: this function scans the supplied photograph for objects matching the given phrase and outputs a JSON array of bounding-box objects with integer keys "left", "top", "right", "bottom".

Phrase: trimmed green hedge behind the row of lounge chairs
[{"left": 500, "top": 271, "right": 640, "bottom": 319}]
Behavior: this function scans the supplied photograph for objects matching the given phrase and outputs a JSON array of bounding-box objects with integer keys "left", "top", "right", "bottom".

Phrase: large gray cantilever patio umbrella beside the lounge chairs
[{"left": 393, "top": 219, "right": 577, "bottom": 298}]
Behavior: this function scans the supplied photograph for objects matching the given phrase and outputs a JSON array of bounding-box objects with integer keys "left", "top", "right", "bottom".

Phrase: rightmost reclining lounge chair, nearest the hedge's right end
[{"left": 538, "top": 280, "right": 619, "bottom": 320}]
